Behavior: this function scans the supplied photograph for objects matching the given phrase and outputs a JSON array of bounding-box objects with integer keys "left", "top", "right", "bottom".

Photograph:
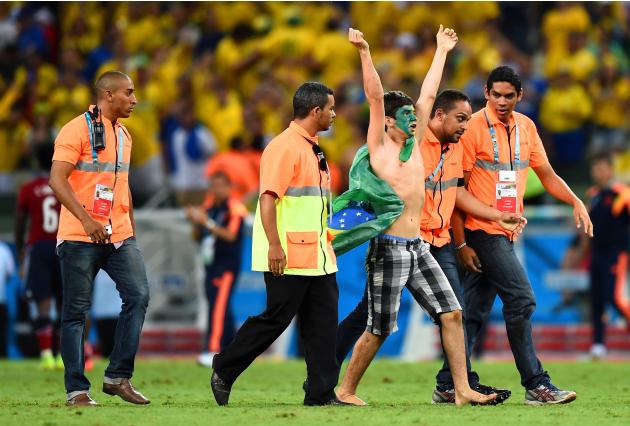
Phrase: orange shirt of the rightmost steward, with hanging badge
[{"left": 460, "top": 104, "right": 549, "bottom": 237}]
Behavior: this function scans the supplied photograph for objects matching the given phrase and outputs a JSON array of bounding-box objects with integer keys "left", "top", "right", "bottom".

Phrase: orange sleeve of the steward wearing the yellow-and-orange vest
[{"left": 260, "top": 141, "right": 298, "bottom": 198}]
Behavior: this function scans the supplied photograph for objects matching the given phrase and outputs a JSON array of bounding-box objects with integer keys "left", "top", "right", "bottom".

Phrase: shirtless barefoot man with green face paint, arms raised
[{"left": 337, "top": 25, "right": 496, "bottom": 405}]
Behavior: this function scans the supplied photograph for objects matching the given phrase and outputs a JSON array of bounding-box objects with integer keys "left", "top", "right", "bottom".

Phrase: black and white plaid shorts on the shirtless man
[{"left": 365, "top": 235, "right": 461, "bottom": 336}]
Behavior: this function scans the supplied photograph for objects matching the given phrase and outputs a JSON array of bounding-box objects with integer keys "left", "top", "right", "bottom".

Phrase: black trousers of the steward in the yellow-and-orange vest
[{"left": 213, "top": 272, "right": 339, "bottom": 404}]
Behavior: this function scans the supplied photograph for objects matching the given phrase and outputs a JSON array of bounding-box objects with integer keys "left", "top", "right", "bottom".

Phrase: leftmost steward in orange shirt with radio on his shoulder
[{"left": 49, "top": 71, "right": 149, "bottom": 406}]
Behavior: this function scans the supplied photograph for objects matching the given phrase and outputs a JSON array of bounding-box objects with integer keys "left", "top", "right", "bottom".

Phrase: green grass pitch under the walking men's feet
[{"left": 0, "top": 359, "right": 630, "bottom": 426}]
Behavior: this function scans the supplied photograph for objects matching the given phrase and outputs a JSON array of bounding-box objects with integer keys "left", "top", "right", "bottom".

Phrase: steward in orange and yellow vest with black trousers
[{"left": 210, "top": 82, "right": 348, "bottom": 405}]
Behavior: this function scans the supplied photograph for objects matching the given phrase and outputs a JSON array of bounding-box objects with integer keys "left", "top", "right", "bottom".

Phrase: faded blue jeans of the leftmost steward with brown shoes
[{"left": 57, "top": 237, "right": 149, "bottom": 393}]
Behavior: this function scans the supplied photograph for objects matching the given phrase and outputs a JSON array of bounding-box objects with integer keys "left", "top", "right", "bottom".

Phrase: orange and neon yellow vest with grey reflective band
[{"left": 252, "top": 121, "right": 337, "bottom": 275}]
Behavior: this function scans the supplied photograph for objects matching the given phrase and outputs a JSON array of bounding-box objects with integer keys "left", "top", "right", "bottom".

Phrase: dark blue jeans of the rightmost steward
[{"left": 463, "top": 229, "right": 550, "bottom": 389}]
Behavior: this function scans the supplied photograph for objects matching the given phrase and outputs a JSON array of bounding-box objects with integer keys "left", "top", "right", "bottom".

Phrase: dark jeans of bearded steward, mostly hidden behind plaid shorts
[{"left": 337, "top": 243, "right": 479, "bottom": 390}]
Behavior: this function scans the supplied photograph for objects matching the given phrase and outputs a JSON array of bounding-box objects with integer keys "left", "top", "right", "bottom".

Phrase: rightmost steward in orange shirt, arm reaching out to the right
[{"left": 452, "top": 66, "right": 593, "bottom": 405}]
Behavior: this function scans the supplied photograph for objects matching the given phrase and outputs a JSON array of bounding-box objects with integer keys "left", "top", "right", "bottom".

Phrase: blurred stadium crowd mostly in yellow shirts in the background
[{"left": 0, "top": 2, "right": 630, "bottom": 208}]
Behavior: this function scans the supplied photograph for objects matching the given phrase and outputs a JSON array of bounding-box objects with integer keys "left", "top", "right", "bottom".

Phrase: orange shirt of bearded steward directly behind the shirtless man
[{"left": 420, "top": 127, "right": 464, "bottom": 247}]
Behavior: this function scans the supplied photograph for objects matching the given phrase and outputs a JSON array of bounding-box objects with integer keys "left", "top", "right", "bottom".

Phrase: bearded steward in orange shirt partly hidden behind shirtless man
[{"left": 337, "top": 90, "right": 524, "bottom": 404}]
